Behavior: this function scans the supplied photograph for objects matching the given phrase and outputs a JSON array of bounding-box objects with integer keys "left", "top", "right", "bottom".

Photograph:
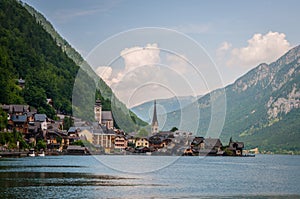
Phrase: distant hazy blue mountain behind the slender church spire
[{"left": 130, "top": 96, "right": 200, "bottom": 123}]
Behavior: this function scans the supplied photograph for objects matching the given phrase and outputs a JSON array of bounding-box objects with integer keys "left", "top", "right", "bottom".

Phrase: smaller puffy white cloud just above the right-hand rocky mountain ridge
[{"left": 226, "top": 31, "right": 291, "bottom": 68}]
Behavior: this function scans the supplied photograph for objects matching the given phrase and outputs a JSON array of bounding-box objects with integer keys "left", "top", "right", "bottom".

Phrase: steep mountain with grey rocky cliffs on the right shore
[{"left": 164, "top": 46, "right": 300, "bottom": 152}]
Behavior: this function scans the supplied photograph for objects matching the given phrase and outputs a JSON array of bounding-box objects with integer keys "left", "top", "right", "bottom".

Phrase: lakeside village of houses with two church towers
[{"left": 0, "top": 99, "right": 251, "bottom": 156}]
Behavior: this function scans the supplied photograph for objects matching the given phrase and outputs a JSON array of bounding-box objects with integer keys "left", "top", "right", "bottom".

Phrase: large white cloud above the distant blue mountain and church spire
[{"left": 95, "top": 43, "right": 206, "bottom": 107}]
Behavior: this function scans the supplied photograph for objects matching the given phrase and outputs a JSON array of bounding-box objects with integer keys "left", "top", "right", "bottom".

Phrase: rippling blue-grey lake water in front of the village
[{"left": 0, "top": 155, "right": 300, "bottom": 198}]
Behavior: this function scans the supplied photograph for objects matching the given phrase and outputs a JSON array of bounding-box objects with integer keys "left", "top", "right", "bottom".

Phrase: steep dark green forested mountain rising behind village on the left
[{"left": 0, "top": 0, "right": 146, "bottom": 132}]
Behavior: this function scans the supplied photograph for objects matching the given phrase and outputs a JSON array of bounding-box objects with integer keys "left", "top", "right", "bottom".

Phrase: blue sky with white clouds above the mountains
[{"left": 24, "top": 0, "right": 300, "bottom": 107}]
